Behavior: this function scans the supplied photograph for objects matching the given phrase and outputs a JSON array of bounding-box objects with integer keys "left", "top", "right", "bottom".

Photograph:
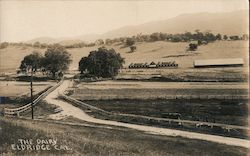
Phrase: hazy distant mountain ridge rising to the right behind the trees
[{"left": 25, "top": 10, "right": 249, "bottom": 43}]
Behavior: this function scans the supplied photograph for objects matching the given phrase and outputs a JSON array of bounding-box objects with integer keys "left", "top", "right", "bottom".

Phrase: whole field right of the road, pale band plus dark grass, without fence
[{"left": 70, "top": 80, "right": 248, "bottom": 138}]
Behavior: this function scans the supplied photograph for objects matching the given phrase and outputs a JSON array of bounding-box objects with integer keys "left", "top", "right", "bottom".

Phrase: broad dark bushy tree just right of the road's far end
[{"left": 79, "top": 47, "right": 124, "bottom": 77}]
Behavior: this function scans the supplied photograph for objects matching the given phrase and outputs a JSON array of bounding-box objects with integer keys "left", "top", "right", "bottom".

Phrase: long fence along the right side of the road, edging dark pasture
[{"left": 59, "top": 94, "right": 250, "bottom": 131}]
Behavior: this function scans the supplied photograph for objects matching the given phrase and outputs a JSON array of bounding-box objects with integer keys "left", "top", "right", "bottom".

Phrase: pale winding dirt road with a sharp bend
[{"left": 45, "top": 80, "right": 250, "bottom": 148}]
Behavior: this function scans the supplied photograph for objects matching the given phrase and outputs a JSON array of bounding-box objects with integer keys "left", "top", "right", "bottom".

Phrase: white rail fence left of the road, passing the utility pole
[{"left": 3, "top": 80, "right": 63, "bottom": 116}]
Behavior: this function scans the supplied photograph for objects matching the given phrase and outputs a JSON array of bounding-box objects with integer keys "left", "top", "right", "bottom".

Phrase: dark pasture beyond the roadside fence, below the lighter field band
[{"left": 84, "top": 99, "right": 248, "bottom": 126}]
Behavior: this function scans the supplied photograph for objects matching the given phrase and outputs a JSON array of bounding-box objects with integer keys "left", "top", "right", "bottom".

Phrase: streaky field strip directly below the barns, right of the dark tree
[{"left": 116, "top": 67, "right": 249, "bottom": 82}]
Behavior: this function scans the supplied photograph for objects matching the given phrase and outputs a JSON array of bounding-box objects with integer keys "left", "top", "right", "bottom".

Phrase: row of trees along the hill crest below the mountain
[{"left": 0, "top": 29, "right": 249, "bottom": 49}]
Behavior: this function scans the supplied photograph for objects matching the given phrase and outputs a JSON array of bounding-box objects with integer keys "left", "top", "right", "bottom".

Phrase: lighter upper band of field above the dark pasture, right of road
[{"left": 72, "top": 81, "right": 248, "bottom": 100}]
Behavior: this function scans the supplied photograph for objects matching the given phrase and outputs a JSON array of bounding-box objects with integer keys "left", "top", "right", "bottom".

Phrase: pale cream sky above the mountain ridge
[{"left": 0, "top": 0, "right": 249, "bottom": 42}]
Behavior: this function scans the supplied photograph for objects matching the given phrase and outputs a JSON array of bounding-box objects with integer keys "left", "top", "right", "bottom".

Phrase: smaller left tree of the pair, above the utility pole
[{"left": 19, "top": 51, "right": 43, "bottom": 73}]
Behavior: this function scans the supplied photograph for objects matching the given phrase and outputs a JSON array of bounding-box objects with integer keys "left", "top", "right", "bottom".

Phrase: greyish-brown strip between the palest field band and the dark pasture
[{"left": 73, "top": 87, "right": 247, "bottom": 100}]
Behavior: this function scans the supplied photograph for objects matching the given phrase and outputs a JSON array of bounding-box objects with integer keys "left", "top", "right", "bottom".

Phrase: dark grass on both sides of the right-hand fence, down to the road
[{"left": 70, "top": 99, "right": 249, "bottom": 139}]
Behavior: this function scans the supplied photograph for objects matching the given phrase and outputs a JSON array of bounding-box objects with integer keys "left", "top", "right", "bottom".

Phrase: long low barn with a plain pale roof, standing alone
[{"left": 194, "top": 58, "right": 244, "bottom": 68}]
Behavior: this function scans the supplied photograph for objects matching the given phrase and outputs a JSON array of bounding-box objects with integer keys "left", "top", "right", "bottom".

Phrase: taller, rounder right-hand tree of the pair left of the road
[{"left": 42, "top": 44, "right": 72, "bottom": 78}]
